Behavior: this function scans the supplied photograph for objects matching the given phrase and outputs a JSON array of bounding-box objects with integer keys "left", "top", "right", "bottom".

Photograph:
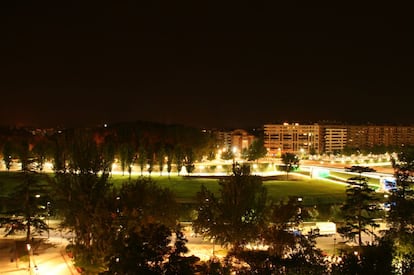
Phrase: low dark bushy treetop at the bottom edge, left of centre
[{"left": 105, "top": 223, "right": 199, "bottom": 275}]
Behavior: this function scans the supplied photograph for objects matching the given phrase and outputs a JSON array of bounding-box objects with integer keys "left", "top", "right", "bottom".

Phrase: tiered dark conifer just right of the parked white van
[{"left": 338, "top": 177, "right": 379, "bottom": 248}]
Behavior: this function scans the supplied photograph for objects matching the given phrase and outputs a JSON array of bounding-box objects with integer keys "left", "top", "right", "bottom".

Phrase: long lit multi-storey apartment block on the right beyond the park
[{"left": 264, "top": 123, "right": 414, "bottom": 157}]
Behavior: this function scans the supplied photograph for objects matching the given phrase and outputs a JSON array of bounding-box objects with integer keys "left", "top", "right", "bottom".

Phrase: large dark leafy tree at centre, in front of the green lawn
[{"left": 193, "top": 163, "right": 267, "bottom": 250}]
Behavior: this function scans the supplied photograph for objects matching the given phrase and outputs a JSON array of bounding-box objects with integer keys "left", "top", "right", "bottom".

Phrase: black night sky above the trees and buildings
[{"left": 0, "top": 0, "right": 414, "bottom": 128}]
